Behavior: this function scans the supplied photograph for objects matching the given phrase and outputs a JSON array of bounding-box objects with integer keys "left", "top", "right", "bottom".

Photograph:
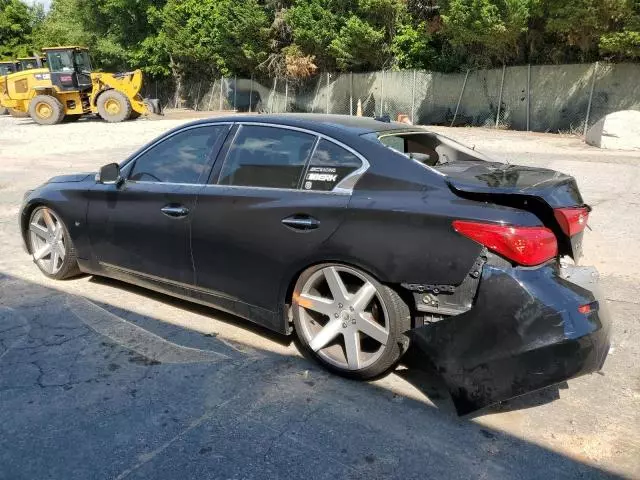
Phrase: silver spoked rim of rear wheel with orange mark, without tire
[{"left": 294, "top": 265, "right": 389, "bottom": 370}]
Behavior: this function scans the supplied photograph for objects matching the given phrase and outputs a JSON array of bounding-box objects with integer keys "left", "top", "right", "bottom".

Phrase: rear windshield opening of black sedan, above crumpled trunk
[{"left": 364, "top": 131, "right": 495, "bottom": 167}]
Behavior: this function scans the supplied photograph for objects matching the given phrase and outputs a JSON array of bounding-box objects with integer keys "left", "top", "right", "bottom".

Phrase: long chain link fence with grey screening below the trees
[{"left": 144, "top": 63, "right": 640, "bottom": 134}]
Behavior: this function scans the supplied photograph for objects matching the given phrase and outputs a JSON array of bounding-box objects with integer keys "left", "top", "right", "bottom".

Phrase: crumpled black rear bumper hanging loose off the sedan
[{"left": 408, "top": 264, "right": 610, "bottom": 415}]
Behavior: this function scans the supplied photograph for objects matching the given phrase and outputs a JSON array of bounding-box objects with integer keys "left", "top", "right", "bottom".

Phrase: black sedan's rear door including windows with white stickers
[{"left": 192, "top": 123, "right": 367, "bottom": 321}]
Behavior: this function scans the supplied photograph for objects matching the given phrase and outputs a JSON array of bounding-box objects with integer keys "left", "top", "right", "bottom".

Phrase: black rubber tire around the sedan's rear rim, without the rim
[{"left": 291, "top": 263, "right": 411, "bottom": 380}]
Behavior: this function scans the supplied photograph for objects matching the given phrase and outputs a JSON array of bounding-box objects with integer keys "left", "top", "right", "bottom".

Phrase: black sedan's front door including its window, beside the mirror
[{"left": 88, "top": 124, "right": 230, "bottom": 285}]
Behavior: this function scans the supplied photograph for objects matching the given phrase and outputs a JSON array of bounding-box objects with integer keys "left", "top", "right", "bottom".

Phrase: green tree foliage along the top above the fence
[{"left": 0, "top": 0, "right": 640, "bottom": 78}]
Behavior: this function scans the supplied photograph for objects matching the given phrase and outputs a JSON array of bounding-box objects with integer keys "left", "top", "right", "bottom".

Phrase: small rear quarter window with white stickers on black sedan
[{"left": 302, "top": 140, "right": 362, "bottom": 190}]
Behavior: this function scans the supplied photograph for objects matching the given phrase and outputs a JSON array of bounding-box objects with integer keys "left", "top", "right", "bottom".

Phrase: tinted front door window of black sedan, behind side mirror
[{"left": 129, "top": 125, "right": 228, "bottom": 183}]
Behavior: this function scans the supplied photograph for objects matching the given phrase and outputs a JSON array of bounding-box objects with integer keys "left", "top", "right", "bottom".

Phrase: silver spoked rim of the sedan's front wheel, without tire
[{"left": 29, "top": 207, "right": 67, "bottom": 275}]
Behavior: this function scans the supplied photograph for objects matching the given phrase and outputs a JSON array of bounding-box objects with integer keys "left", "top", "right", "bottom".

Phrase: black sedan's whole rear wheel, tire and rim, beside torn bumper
[{"left": 291, "top": 264, "right": 411, "bottom": 380}]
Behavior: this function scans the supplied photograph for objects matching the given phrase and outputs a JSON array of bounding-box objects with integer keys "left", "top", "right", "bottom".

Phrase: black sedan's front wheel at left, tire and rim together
[{"left": 28, "top": 207, "right": 80, "bottom": 280}]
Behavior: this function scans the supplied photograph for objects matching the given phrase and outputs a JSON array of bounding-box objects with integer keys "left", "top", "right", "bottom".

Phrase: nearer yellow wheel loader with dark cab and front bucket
[{"left": 0, "top": 46, "right": 161, "bottom": 125}]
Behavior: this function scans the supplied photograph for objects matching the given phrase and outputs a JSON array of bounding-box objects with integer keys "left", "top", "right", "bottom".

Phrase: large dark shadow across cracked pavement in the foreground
[{"left": 0, "top": 273, "right": 616, "bottom": 480}]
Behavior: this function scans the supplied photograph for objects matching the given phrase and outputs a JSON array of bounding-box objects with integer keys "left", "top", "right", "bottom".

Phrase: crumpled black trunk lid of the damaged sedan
[{"left": 434, "top": 160, "right": 583, "bottom": 208}]
